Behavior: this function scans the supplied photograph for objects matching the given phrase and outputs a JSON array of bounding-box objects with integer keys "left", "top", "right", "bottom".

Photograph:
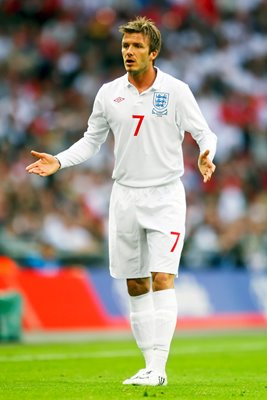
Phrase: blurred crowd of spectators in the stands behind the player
[{"left": 0, "top": 0, "right": 267, "bottom": 271}]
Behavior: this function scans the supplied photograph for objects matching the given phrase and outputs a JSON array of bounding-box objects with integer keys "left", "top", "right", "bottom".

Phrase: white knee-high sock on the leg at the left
[{"left": 130, "top": 292, "right": 154, "bottom": 367}]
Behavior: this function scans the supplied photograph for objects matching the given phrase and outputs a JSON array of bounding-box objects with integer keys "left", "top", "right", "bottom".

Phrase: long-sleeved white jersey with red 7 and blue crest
[{"left": 56, "top": 69, "right": 217, "bottom": 187}]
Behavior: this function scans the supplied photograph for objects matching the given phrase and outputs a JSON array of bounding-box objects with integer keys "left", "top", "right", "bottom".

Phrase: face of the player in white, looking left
[{"left": 122, "top": 33, "right": 157, "bottom": 75}]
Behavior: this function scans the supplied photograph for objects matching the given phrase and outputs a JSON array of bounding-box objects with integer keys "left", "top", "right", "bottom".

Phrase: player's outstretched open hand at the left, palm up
[{"left": 26, "top": 150, "right": 60, "bottom": 176}]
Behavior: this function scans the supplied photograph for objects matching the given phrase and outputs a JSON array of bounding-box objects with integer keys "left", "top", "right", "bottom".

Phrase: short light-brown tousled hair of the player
[{"left": 119, "top": 17, "right": 161, "bottom": 53}]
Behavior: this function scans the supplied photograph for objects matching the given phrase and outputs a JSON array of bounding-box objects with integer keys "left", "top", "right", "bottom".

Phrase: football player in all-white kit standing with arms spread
[{"left": 26, "top": 17, "right": 216, "bottom": 386}]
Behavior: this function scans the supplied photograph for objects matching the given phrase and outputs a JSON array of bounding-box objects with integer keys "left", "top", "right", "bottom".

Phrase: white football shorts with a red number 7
[{"left": 109, "top": 180, "right": 186, "bottom": 279}]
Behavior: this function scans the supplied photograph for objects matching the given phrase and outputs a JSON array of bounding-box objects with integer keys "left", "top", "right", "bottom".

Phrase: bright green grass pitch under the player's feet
[{"left": 0, "top": 332, "right": 267, "bottom": 400}]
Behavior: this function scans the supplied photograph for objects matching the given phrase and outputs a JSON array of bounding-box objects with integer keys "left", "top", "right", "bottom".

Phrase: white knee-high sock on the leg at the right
[{"left": 149, "top": 289, "right": 177, "bottom": 374}]
